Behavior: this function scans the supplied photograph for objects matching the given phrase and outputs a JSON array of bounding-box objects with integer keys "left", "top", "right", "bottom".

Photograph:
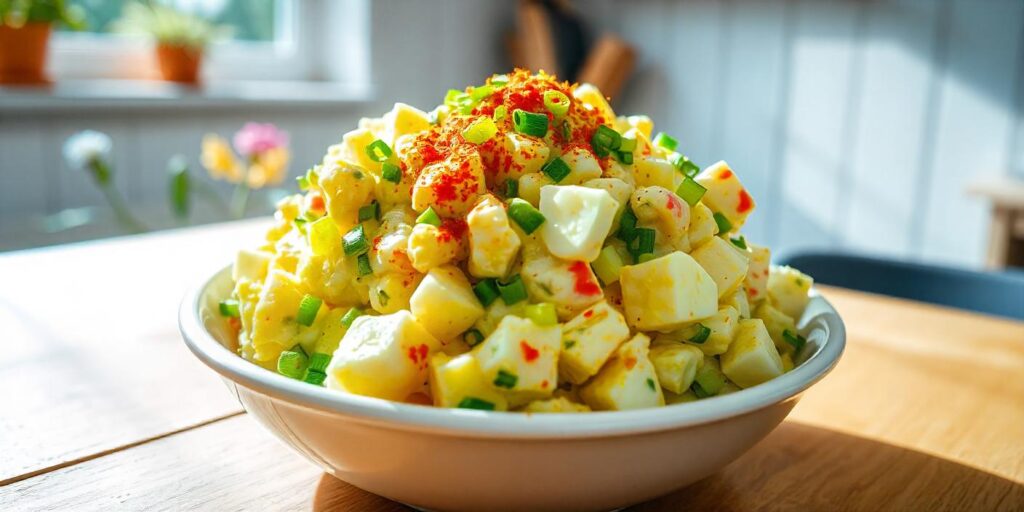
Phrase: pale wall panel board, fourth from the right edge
[{"left": 712, "top": 1, "right": 785, "bottom": 243}]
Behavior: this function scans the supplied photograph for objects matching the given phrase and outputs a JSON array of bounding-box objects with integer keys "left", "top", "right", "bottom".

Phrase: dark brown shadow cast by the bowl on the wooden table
[{"left": 313, "top": 422, "right": 1024, "bottom": 512}]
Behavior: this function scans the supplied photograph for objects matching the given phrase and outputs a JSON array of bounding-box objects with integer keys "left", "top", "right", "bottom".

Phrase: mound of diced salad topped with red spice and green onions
[{"left": 220, "top": 70, "right": 812, "bottom": 413}]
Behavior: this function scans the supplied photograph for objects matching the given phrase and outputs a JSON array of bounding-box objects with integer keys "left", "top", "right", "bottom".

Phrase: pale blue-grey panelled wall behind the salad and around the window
[{"left": 0, "top": 0, "right": 1024, "bottom": 265}]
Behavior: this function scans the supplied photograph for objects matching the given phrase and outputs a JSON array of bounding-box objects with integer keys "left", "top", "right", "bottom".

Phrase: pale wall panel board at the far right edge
[{"left": 914, "top": 0, "right": 1024, "bottom": 264}]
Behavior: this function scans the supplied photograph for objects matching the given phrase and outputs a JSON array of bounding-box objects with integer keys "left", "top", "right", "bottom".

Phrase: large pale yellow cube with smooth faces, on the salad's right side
[{"left": 618, "top": 252, "right": 718, "bottom": 331}]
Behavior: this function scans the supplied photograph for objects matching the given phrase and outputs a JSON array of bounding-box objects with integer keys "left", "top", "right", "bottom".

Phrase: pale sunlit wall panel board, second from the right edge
[{"left": 842, "top": 0, "right": 939, "bottom": 256}]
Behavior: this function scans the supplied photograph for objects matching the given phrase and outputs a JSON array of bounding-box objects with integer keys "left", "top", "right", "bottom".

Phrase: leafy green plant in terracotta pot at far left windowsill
[{"left": 0, "top": 0, "right": 85, "bottom": 85}]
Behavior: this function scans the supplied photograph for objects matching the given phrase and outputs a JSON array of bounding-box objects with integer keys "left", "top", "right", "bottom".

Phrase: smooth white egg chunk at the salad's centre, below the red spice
[{"left": 541, "top": 185, "right": 618, "bottom": 261}]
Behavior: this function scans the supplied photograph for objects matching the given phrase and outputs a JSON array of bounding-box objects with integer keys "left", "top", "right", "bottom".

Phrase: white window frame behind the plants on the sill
[{"left": 48, "top": 0, "right": 344, "bottom": 83}]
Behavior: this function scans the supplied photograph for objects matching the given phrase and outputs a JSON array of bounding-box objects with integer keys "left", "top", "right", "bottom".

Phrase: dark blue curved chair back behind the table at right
[{"left": 778, "top": 252, "right": 1024, "bottom": 321}]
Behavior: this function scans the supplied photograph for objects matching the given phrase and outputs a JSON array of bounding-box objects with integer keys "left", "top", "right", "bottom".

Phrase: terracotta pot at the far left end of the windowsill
[{"left": 0, "top": 23, "right": 50, "bottom": 85}]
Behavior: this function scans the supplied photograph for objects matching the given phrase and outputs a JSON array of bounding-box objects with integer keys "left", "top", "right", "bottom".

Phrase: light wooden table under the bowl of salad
[{"left": 0, "top": 221, "right": 1024, "bottom": 511}]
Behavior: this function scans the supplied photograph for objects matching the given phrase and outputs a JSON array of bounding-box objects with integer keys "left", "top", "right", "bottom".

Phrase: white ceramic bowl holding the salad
[{"left": 179, "top": 269, "right": 846, "bottom": 511}]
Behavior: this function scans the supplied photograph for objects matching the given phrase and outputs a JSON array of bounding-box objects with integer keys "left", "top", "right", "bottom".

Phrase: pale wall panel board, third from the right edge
[{"left": 769, "top": 2, "right": 862, "bottom": 250}]
